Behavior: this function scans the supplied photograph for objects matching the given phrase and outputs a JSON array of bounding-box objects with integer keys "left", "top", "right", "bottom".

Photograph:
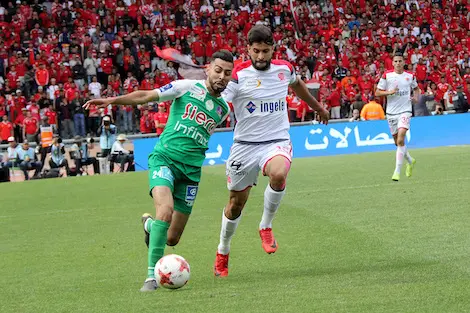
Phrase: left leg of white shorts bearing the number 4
[{"left": 225, "top": 143, "right": 260, "bottom": 191}]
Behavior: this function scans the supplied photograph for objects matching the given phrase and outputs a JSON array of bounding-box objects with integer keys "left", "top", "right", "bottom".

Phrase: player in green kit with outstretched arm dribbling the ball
[{"left": 84, "top": 50, "right": 233, "bottom": 291}]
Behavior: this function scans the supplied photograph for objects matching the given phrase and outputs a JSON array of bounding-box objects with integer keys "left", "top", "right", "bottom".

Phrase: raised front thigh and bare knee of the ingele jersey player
[{"left": 259, "top": 141, "right": 292, "bottom": 177}]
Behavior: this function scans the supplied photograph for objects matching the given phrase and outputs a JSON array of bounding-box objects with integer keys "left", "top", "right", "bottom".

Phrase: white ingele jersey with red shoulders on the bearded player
[{"left": 222, "top": 60, "right": 297, "bottom": 142}]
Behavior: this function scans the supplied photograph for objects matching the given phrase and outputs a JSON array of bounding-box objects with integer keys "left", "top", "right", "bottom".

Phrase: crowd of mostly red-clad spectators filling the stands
[{"left": 0, "top": 0, "right": 470, "bottom": 142}]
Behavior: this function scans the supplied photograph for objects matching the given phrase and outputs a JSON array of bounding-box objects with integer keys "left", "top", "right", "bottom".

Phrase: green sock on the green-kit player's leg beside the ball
[{"left": 147, "top": 220, "right": 170, "bottom": 278}]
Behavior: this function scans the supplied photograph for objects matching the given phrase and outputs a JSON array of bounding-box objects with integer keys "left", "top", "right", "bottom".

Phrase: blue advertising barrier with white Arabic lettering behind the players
[{"left": 134, "top": 114, "right": 470, "bottom": 170}]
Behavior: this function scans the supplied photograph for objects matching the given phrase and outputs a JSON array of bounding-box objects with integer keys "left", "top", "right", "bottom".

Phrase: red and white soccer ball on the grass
[{"left": 155, "top": 254, "right": 190, "bottom": 289}]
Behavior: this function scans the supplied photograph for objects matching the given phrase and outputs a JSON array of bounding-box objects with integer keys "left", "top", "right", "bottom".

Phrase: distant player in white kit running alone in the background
[{"left": 375, "top": 54, "right": 420, "bottom": 181}]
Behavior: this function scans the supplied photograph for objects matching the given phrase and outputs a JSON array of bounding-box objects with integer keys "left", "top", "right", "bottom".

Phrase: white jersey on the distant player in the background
[{"left": 377, "top": 71, "right": 418, "bottom": 115}]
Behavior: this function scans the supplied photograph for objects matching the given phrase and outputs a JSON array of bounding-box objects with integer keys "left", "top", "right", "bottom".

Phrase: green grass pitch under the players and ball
[{"left": 0, "top": 147, "right": 470, "bottom": 313}]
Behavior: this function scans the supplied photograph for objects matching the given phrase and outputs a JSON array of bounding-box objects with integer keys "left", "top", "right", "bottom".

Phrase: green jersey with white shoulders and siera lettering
[{"left": 154, "top": 79, "right": 230, "bottom": 167}]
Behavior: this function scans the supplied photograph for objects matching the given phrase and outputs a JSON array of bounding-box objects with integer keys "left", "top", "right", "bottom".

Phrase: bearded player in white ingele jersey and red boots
[{"left": 214, "top": 25, "right": 329, "bottom": 276}]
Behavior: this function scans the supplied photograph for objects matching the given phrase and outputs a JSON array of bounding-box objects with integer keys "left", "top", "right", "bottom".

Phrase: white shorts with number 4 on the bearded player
[{"left": 225, "top": 140, "right": 292, "bottom": 191}]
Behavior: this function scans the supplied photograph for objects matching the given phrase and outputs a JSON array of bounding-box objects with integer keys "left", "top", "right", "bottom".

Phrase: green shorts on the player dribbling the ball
[{"left": 148, "top": 151, "right": 201, "bottom": 215}]
